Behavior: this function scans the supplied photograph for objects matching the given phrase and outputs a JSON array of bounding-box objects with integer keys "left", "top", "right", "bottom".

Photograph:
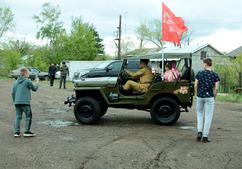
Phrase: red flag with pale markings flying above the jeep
[{"left": 162, "top": 2, "right": 188, "bottom": 46}]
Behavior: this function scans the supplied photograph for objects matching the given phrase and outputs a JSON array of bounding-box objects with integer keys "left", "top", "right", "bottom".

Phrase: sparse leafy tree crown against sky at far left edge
[{"left": 0, "top": 7, "right": 15, "bottom": 38}]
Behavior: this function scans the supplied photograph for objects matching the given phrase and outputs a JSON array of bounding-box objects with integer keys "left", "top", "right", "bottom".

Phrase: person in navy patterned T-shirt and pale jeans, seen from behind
[{"left": 194, "top": 58, "right": 220, "bottom": 143}]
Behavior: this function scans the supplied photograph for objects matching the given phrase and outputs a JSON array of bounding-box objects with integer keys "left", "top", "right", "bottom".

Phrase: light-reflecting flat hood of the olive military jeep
[{"left": 74, "top": 77, "right": 117, "bottom": 87}]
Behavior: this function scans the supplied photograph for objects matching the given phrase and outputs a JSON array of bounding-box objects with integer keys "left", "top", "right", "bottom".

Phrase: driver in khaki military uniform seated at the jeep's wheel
[{"left": 123, "top": 59, "right": 154, "bottom": 94}]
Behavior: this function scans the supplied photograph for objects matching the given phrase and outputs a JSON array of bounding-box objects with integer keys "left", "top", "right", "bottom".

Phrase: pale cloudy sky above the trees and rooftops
[{"left": 0, "top": 0, "right": 242, "bottom": 55}]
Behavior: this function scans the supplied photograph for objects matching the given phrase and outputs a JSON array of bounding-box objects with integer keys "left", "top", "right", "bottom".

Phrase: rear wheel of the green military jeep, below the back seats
[{"left": 150, "top": 97, "right": 180, "bottom": 125}]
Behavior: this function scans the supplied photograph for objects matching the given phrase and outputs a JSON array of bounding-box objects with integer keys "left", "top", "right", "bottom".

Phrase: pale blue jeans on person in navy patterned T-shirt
[{"left": 197, "top": 97, "right": 214, "bottom": 137}]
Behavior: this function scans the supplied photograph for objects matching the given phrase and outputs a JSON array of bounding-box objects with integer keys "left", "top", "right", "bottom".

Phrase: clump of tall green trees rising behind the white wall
[{"left": 33, "top": 3, "right": 104, "bottom": 63}]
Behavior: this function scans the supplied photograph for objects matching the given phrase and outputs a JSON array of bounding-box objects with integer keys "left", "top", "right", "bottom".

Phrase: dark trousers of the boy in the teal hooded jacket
[{"left": 14, "top": 105, "right": 32, "bottom": 132}]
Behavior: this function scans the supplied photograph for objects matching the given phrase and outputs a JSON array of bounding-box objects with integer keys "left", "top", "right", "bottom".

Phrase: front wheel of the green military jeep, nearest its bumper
[{"left": 74, "top": 97, "right": 101, "bottom": 124}]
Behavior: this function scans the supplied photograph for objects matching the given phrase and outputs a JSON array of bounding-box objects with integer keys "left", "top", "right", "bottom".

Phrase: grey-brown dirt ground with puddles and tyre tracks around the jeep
[{"left": 0, "top": 79, "right": 242, "bottom": 169}]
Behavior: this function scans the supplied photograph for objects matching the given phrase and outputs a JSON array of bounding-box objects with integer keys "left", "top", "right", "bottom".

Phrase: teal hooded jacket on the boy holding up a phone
[{"left": 12, "top": 76, "right": 39, "bottom": 105}]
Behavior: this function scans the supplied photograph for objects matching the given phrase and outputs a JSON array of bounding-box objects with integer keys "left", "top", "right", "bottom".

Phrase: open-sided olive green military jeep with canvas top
[{"left": 65, "top": 52, "right": 194, "bottom": 125}]
